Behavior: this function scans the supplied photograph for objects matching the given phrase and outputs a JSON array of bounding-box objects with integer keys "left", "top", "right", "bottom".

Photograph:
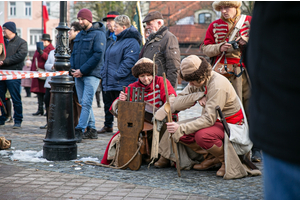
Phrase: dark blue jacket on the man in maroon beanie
[{"left": 70, "top": 22, "right": 106, "bottom": 78}]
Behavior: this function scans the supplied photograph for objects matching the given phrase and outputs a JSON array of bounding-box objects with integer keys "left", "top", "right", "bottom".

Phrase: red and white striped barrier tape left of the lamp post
[{"left": 0, "top": 70, "right": 69, "bottom": 81}]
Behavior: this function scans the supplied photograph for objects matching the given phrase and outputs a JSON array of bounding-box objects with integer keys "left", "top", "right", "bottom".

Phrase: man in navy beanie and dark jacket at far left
[{"left": 0, "top": 22, "right": 28, "bottom": 128}]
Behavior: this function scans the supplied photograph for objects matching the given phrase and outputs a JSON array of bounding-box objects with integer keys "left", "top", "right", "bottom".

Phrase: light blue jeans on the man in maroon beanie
[{"left": 75, "top": 76, "right": 100, "bottom": 131}]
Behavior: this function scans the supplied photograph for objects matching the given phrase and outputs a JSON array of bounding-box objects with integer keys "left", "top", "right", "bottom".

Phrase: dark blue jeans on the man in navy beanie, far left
[{"left": 0, "top": 79, "right": 23, "bottom": 123}]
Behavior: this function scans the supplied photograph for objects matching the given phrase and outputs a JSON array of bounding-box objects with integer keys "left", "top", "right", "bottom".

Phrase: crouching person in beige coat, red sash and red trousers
[{"left": 155, "top": 55, "right": 260, "bottom": 179}]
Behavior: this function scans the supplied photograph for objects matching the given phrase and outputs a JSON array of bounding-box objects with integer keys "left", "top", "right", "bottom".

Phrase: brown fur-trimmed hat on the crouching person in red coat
[{"left": 131, "top": 58, "right": 157, "bottom": 78}]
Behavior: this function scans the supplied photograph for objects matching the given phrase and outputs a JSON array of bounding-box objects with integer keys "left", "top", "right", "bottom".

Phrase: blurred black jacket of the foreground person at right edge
[{"left": 246, "top": 1, "right": 300, "bottom": 164}]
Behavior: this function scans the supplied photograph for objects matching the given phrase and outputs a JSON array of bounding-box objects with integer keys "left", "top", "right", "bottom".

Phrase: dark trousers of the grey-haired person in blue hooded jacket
[{"left": 102, "top": 90, "right": 120, "bottom": 128}]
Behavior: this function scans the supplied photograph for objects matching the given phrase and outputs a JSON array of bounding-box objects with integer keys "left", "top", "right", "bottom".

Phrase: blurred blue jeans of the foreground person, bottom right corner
[{"left": 263, "top": 152, "right": 300, "bottom": 200}]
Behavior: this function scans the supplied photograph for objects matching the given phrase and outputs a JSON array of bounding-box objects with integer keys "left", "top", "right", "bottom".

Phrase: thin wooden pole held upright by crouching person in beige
[{"left": 163, "top": 72, "right": 181, "bottom": 177}]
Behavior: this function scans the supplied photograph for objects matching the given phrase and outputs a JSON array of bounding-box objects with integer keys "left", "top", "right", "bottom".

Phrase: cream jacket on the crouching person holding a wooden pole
[{"left": 171, "top": 71, "right": 241, "bottom": 142}]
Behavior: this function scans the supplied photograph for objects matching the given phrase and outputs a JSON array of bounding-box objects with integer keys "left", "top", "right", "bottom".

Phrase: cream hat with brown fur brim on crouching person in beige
[{"left": 180, "top": 55, "right": 212, "bottom": 82}]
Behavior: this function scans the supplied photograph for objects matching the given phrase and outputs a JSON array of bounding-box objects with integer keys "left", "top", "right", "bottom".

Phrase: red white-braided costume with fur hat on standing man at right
[{"left": 201, "top": 1, "right": 251, "bottom": 113}]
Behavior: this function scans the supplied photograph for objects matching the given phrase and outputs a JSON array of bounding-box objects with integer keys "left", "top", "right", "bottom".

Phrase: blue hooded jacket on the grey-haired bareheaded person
[{"left": 101, "top": 26, "right": 141, "bottom": 91}]
